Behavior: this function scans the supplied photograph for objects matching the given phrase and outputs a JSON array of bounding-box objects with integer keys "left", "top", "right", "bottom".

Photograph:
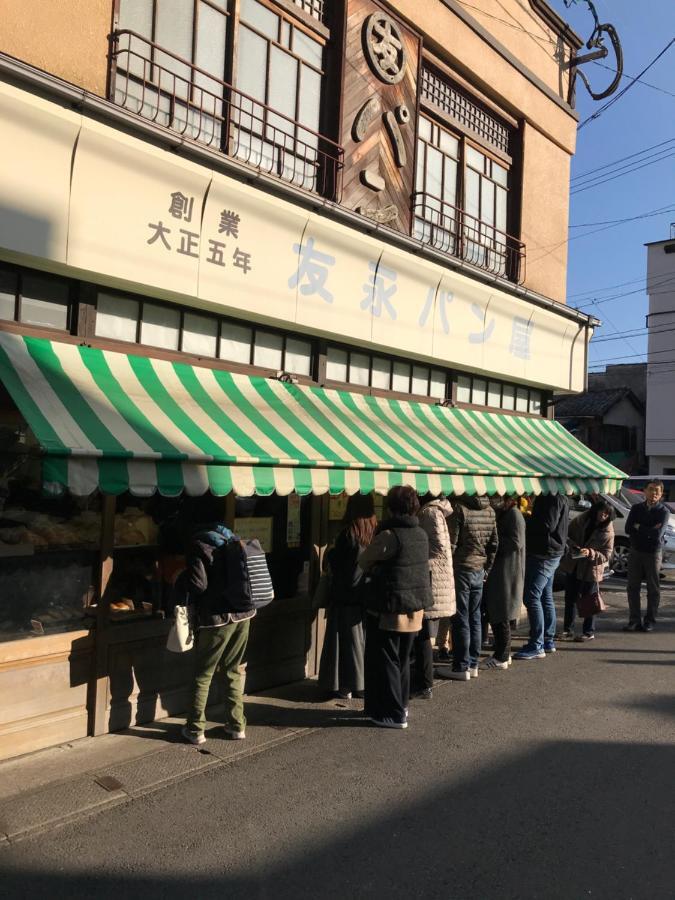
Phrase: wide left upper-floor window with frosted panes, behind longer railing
[{"left": 110, "top": 0, "right": 342, "bottom": 199}]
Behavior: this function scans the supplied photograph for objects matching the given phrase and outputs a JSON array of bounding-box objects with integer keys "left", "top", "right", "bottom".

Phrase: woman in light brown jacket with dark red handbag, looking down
[{"left": 560, "top": 500, "right": 614, "bottom": 641}]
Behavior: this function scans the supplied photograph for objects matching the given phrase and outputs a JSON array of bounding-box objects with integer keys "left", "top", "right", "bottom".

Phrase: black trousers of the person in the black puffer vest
[{"left": 364, "top": 613, "right": 415, "bottom": 722}]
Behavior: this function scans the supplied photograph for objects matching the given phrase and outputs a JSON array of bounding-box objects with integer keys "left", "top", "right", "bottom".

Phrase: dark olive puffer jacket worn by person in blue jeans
[{"left": 448, "top": 497, "right": 499, "bottom": 574}]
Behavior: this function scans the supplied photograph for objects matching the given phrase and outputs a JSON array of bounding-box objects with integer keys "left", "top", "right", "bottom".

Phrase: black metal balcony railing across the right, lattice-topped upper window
[{"left": 413, "top": 193, "right": 525, "bottom": 284}]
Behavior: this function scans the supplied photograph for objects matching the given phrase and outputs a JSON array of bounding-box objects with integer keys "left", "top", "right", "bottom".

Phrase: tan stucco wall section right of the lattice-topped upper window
[{"left": 521, "top": 123, "right": 571, "bottom": 302}]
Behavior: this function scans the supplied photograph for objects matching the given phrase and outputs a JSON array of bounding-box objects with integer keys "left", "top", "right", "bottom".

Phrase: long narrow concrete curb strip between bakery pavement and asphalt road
[{"left": 0, "top": 728, "right": 320, "bottom": 851}]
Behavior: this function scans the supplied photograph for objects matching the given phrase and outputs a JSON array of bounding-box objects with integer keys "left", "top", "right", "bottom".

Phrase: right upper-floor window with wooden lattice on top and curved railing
[{"left": 414, "top": 68, "right": 524, "bottom": 281}]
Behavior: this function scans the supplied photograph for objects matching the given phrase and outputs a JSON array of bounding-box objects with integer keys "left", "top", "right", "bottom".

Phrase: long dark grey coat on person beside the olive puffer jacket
[{"left": 483, "top": 507, "right": 525, "bottom": 625}]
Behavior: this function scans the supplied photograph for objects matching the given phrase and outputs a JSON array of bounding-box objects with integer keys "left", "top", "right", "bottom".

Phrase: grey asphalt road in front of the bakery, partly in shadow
[{"left": 0, "top": 583, "right": 675, "bottom": 900}]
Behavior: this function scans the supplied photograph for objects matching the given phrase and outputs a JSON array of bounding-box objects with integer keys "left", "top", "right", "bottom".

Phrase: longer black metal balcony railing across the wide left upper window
[{"left": 109, "top": 30, "right": 344, "bottom": 202}]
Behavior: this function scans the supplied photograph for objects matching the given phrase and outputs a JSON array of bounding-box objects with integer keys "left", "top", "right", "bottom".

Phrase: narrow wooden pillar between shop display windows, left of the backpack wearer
[{"left": 87, "top": 494, "right": 117, "bottom": 735}]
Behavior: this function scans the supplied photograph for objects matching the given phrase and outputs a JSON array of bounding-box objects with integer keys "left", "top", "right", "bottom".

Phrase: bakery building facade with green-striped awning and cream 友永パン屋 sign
[{"left": 0, "top": 0, "right": 621, "bottom": 758}]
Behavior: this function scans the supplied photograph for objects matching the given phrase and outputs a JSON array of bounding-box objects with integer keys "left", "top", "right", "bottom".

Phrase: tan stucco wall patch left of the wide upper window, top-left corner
[{"left": 0, "top": 0, "right": 113, "bottom": 96}]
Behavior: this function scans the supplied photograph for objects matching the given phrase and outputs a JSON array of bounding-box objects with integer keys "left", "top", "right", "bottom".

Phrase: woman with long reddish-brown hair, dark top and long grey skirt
[{"left": 319, "top": 494, "right": 377, "bottom": 700}]
